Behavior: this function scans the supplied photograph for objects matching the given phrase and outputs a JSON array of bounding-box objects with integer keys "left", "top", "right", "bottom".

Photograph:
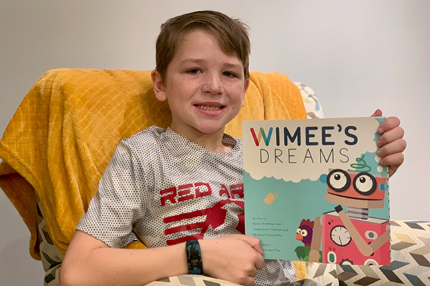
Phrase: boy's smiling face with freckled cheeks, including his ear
[{"left": 152, "top": 30, "right": 249, "bottom": 139}]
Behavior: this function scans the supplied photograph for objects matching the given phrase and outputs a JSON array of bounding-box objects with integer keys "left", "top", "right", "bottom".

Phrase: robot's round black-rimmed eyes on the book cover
[{"left": 327, "top": 169, "right": 377, "bottom": 196}]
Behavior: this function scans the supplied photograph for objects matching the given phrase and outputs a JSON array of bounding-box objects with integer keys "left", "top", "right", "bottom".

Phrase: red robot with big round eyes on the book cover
[{"left": 309, "top": 169, "right": 390, "bottom": 265}]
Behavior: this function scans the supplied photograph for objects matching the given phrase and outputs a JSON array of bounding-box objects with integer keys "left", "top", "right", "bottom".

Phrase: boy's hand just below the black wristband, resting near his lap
[{"left": 199, "top": 234, "right": 264, "bottom": 285}]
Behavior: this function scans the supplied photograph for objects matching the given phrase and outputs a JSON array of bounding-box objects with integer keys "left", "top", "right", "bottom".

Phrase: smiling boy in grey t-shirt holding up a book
[{"left": 61, "top": 11, "right": 404, "bottom": 285}]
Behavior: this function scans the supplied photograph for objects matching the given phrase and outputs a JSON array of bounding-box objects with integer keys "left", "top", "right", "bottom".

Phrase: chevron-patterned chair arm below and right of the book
[{"left": 306, "top": 220, "right": 430, "bottom": 286}]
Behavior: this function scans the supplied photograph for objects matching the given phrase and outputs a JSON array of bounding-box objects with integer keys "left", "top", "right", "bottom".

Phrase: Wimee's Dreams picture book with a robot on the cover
[{"left": 242, "top": 117, "right": 390, "bottom": 265}]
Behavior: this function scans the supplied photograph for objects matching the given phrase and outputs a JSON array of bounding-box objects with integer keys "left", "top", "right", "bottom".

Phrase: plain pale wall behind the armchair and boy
[{"left": 0, "top": 0, "right": 430, "bottom": 285}]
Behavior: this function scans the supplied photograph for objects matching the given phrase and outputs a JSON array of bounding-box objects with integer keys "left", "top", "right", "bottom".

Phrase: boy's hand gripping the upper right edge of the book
[{"left": 372, "top": 109, "right": 406, "bottom": 177}]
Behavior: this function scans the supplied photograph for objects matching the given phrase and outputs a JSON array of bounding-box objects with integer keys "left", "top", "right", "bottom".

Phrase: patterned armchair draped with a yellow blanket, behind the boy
[{"left": 0, "top": 69, "right": 430, "bottom": 286}]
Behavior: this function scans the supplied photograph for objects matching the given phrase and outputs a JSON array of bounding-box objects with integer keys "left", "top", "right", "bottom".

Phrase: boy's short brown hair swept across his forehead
[{"left": 156, "top": 11, "right": 251, "bottom": 81}]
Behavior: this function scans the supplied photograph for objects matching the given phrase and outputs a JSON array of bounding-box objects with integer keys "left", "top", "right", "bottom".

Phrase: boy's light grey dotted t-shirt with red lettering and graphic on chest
[{"left": 77, "top": 126, "right": 295, "bottom": 285}]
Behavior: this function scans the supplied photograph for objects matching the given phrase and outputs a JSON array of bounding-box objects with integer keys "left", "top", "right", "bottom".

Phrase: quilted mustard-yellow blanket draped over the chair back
[{"left": 0, "top": 69, "right": 306, "bottom": 259}]
